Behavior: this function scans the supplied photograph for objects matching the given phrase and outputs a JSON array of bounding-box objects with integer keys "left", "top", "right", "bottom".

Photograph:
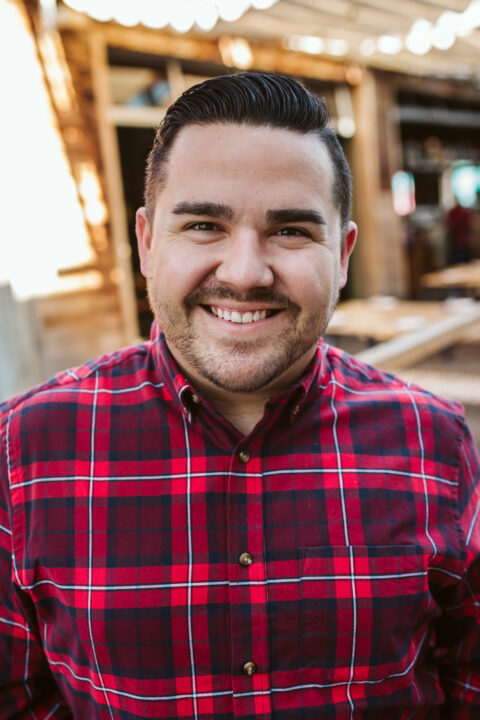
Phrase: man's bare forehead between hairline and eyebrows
[{"left": 166, "top": 123, "right": 334, "bottom": 204}]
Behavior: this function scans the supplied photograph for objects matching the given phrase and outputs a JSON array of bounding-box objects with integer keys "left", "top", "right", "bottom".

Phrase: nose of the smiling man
[{"left": 216, "top": 229, "right": 275, "bottom": 290}]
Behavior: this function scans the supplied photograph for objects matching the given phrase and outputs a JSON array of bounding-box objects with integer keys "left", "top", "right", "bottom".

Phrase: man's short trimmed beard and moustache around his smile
[{"left": 147, "top": 280, "right": 339, "bottom": 393}]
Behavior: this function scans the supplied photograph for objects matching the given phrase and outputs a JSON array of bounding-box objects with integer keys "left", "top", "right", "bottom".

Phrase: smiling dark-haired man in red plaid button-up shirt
[{"left": 0, "top": 73, "right": 480, "bottom": 720}]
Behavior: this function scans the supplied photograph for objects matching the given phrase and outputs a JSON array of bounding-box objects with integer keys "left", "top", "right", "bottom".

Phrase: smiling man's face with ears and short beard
[{"left": 137, "top": 124, "right": 356, "bottom": 393}]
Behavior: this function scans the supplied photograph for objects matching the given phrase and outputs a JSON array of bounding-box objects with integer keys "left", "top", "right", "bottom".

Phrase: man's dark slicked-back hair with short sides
[{"left": 145, "top": 72, "right": 352, "bottom": 230}]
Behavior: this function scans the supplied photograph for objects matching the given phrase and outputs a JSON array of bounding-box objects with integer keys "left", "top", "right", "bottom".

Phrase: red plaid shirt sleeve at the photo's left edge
[{"left": 0, "top": 416, "right": 73, "bottom": 720}]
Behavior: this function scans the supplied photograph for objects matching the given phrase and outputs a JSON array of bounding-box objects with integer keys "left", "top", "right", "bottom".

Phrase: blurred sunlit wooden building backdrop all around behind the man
[{"left": 0, "top": 0, "right": 480, "bottom": 441}]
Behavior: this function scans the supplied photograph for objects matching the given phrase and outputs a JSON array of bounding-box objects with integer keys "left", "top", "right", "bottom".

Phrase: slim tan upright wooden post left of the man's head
[{"left": 89, "top": 32, "right": 139, "bottom": 344}]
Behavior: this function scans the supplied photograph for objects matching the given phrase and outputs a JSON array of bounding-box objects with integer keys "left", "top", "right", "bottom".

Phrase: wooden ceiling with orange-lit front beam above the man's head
[{"left": 56, "top": 0, "right": 480, "bottom": 85}]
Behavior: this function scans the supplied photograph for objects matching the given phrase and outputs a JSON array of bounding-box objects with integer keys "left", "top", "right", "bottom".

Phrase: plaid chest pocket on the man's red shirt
[{"left": 299, "top": 546, "right": 436, "bottom": 690}]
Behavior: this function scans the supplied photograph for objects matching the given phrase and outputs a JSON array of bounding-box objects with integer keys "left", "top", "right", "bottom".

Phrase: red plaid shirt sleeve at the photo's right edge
[{"left": 436, "top": 428, "right": 480, "bottom": 720}]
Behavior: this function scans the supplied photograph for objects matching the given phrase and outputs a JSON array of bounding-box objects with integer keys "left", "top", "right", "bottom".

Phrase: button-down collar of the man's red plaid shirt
[{"left": 150, "top": 321, "right": 327, "bottom": 422}]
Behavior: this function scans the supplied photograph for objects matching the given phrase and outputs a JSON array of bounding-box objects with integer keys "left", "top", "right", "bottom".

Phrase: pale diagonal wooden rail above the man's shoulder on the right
[{"left": 357, "top": 306, "right": 480, "bottom": 372}]
